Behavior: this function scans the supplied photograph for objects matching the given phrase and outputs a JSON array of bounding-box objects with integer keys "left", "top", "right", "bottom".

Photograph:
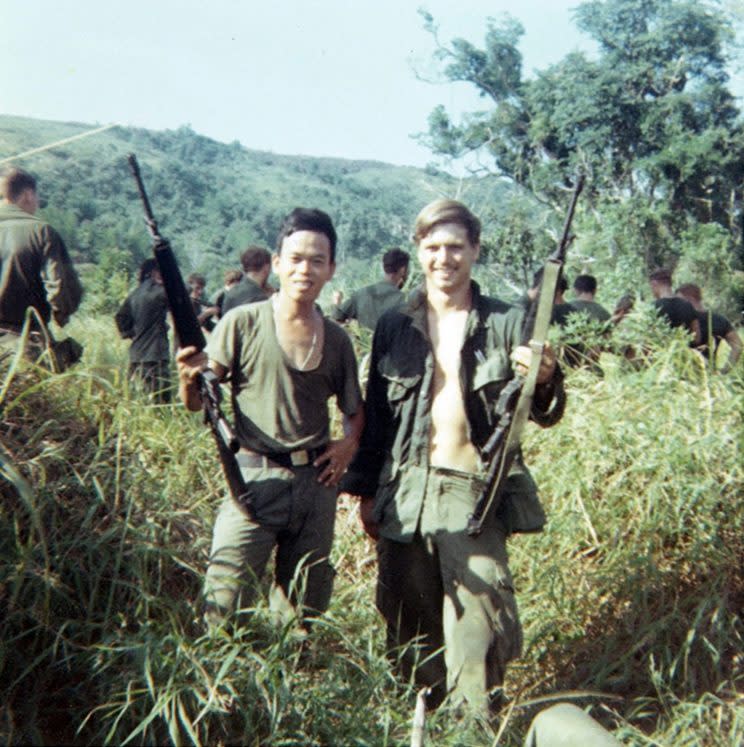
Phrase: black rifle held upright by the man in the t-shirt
[{"left": 127, "top": 153, "right": 251, "bottom": 509}]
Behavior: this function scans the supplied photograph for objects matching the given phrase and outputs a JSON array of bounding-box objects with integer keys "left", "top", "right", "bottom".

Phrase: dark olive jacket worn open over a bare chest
[{"left": 342, "top": 282, "right": 565, "bottom": 542}]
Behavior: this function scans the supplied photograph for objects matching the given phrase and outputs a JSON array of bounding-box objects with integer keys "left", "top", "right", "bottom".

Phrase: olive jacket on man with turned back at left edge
[{"left": 0, "top": 203, "right": 83, "bottom": 331}]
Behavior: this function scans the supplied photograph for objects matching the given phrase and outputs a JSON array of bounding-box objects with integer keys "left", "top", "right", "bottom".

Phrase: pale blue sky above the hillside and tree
[{"left": 0, "top": 0, "right": 740, "bottom": 166}]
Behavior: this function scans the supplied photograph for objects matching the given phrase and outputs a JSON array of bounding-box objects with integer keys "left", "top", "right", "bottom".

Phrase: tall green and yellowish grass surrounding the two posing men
[{"left": 0, "top": 319, "right": 744, "bottom": 747}]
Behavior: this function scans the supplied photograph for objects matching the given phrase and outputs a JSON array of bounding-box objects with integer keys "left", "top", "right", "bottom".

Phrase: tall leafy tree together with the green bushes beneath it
[{"left": 424, "top": 0, "right": 744, "bottom": 316}]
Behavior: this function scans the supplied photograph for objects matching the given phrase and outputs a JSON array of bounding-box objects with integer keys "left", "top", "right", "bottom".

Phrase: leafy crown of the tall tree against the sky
[{"left": 425, "top": 0, "right": 743, "bottom": 219}]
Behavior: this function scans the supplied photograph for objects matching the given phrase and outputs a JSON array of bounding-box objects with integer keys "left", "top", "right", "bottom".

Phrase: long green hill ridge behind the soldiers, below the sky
[{"left": 0, "top": 115, "right": 509, "bottom": 284}]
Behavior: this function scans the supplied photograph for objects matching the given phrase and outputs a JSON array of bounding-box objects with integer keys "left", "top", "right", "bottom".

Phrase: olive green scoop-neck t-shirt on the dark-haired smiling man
[{"left": 207, "top": 301, "right": 362, "bottom": 453}]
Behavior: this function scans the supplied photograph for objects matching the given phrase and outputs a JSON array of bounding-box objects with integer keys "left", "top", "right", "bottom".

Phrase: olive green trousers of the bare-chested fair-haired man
[{"left": 377, "top": 467, "right": 522, "bottom": 713}]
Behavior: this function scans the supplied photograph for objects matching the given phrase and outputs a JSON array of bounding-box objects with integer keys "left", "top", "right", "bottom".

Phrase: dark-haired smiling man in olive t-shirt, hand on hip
[{"left": 176, "top": 208, "right": 364, "bottom": 623}]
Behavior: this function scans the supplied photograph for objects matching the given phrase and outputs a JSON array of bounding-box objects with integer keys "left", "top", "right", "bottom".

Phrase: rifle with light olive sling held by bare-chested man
[{"left": 467, "top": 176, "right": 584, "bottom": 537}]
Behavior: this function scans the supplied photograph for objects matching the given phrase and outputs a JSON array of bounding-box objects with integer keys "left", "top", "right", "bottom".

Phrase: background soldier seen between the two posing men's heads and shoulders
[{"left": 331, "top": 247, "right": 411, "bottom": 331}]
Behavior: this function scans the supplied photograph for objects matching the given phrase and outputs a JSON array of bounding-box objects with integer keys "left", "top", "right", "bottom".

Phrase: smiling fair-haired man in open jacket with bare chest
[{"left": 343, "top": 200, "right": 564, "bottom": 713}]
